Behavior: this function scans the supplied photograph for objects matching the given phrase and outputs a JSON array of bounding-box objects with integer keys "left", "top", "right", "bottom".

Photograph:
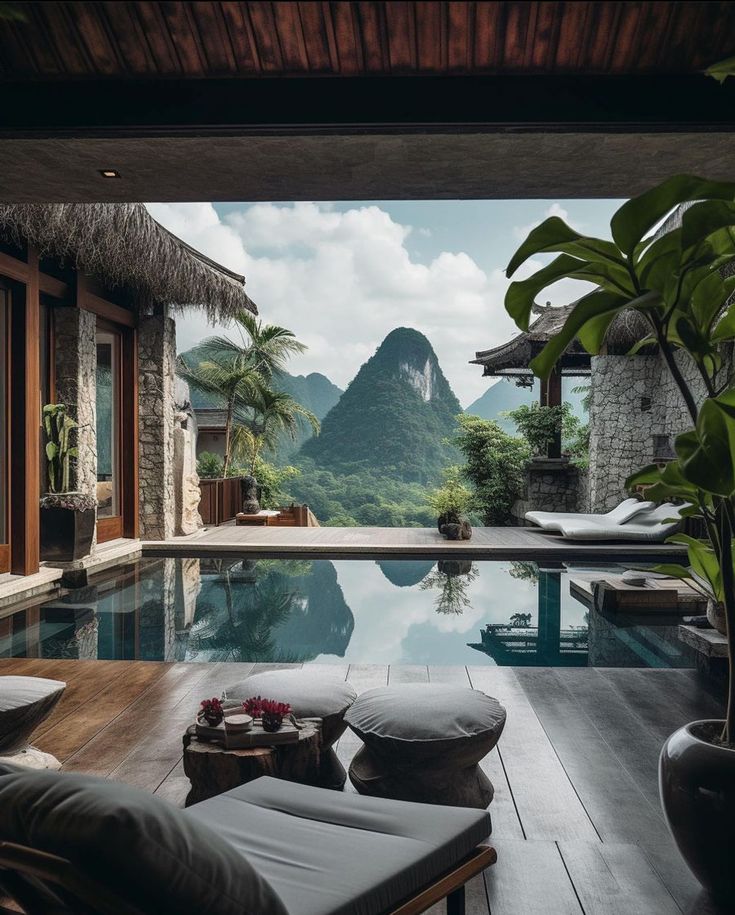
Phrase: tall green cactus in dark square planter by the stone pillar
[{"left": 41, "top": 404, "right": 97, "bottom": 562}]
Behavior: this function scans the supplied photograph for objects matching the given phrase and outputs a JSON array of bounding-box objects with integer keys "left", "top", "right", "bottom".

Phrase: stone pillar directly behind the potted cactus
[{"left": 53, "top": 308, "right": 97, "bottom": 544}]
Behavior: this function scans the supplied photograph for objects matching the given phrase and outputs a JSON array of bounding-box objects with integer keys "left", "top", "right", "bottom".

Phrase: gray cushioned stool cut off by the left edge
[{"left": 0, "top": 677, "right": 66, "bottom": 756}]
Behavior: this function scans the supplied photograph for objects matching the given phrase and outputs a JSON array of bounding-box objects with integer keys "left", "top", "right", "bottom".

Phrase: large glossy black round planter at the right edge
[{"left": 659, "top": 721, "right": 735, "bottom": 905}]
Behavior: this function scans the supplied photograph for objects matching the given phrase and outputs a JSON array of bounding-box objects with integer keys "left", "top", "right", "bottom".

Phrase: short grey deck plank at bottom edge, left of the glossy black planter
[{"left": 559, "top": 842, "right": 681, "bottom": 915}]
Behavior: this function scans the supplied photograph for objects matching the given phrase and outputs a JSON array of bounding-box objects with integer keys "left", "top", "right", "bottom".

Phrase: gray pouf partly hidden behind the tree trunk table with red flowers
[{"left": 225, "top": 667, "right": 357, "bottom": 789}]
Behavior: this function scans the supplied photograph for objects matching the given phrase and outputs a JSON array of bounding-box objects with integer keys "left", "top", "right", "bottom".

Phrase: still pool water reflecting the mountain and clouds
[{"left": 0, "top": 557, "right": 694, "bottom": 667}]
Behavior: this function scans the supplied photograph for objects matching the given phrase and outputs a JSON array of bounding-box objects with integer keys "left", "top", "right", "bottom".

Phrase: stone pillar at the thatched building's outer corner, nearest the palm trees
[{"left": 138, "top": 314, "right": 176, "bottom": 540}]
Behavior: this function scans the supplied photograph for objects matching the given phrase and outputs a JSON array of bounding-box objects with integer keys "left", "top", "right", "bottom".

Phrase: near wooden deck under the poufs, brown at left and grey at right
[{"left": 0, "top": 659, "right": 724, "bottom": 915}]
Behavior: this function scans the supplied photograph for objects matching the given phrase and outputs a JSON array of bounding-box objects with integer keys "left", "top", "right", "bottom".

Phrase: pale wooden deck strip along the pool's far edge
[{"left": 143, "top": 524, "right": 683, "bottom": 562}]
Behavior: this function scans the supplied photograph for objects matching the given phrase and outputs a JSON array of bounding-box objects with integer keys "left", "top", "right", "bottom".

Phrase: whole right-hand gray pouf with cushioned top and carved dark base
[{"left": 345, "top": 683, "right": 505, "bottom": 808}]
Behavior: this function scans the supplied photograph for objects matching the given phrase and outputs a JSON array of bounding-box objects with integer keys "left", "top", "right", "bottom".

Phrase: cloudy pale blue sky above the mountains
[{"left": 148, "top": 200, "right": 621, "bottom": 407}]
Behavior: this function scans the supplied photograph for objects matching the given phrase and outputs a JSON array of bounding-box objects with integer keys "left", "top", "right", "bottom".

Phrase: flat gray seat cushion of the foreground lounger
[{"left": 186, "top": 778, "right": 490, "bottom": 915}]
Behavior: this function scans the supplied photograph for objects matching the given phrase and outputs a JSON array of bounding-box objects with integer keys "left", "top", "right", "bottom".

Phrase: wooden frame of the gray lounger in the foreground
[{"left": 0, "top": 842, "right": 498, "bottom": 915}]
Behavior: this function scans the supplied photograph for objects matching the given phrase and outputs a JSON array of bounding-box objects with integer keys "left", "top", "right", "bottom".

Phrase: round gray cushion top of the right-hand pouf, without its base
[{"left": 345, "top": 683, "right": 505, "bottom": 767}]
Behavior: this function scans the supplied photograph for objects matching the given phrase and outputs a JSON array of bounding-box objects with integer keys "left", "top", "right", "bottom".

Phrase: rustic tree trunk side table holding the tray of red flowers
[{"left": 183, "top": 718, "right": 321, "bottom": 807}]
